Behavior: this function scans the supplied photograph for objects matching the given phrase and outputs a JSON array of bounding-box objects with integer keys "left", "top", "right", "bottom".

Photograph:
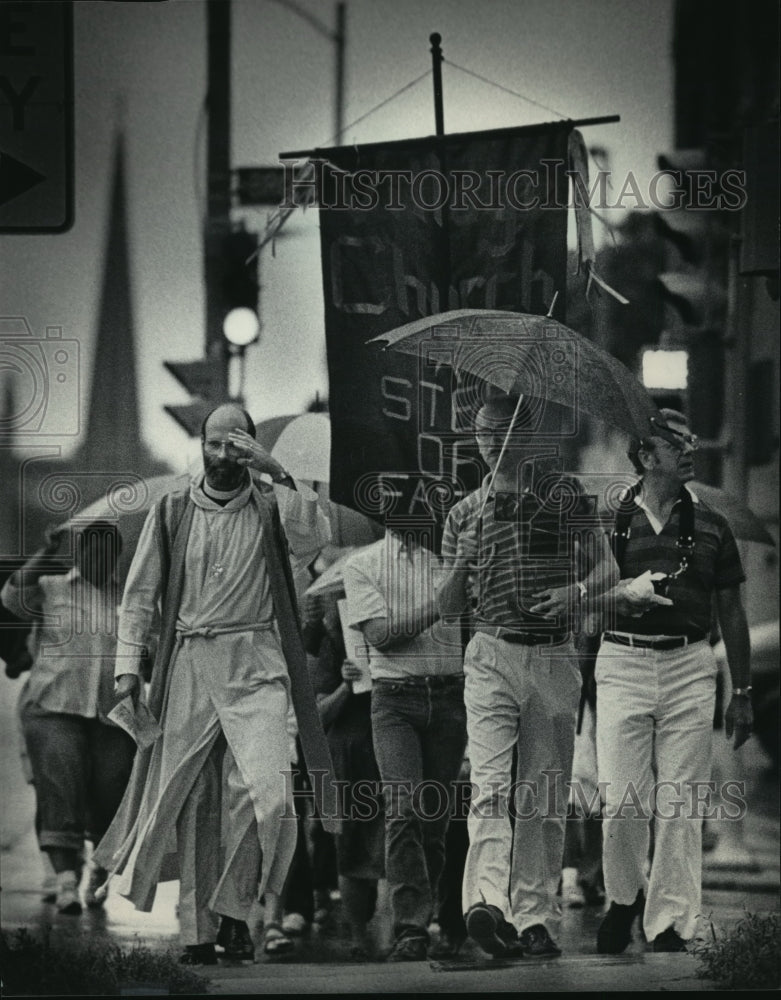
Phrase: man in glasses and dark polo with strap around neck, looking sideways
[{"left": 596, "top": 410, "right": 752, "bottom": 954}]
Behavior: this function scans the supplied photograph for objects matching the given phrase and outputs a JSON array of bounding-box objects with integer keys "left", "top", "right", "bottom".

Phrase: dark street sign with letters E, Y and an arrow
[{"left": 0, "top": 0, "right": 73, "bottom": 233}]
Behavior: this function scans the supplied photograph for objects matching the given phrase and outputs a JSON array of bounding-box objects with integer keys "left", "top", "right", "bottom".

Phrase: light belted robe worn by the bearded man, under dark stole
[{"left": 98, "top": 476, "right": 327, "bottom": 944}]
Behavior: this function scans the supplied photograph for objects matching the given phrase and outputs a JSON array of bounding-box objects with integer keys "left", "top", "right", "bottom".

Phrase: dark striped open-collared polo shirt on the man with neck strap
[{"left": 610, "top": 487, "right": 746, "bottom": 637}]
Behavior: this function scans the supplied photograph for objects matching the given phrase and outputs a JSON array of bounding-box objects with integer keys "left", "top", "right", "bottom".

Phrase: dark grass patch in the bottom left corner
[{"left": 2, "top": 929, "right": 209, "bottom": 996}]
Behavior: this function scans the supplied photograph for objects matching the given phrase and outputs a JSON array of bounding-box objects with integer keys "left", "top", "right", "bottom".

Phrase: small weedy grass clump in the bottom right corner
[{"left": 693, "top": 912, "right": 781, "bottom": 990}]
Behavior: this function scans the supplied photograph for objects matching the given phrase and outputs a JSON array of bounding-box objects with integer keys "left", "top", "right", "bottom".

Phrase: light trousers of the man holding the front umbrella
[{"left": 462, "top": 632, "right": 581, "bottom": 933}]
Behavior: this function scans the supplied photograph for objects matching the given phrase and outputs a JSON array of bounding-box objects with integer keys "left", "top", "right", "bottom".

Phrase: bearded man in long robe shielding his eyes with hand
[{"left": 94, "top": 404, "right": 336, "bottom": 964}]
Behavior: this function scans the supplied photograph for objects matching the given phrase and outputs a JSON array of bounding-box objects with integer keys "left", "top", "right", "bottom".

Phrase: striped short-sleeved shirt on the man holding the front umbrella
[{"left": 442, "top": 474, "right": 593, "bottom": 638}]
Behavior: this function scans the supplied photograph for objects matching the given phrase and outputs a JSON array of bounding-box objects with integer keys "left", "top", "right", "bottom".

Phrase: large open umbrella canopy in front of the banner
[{"left": 369, "top": 309, "right": 661, "bottom": 437}]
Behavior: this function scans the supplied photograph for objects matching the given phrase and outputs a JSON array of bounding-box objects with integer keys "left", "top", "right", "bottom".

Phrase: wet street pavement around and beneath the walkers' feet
[{"left": 0, "top": 678, "right": 780, "bottom": 996}]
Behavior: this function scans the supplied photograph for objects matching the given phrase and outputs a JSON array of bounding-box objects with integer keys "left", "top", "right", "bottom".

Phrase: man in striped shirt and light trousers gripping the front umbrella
[{"left": 439, "top": 392, "right": 618, "bottom": 957}]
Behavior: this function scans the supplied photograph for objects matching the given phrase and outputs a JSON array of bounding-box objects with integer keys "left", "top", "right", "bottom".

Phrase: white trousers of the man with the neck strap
[{"left": 596, "top": 641, "right": 718, "bottom": 941}]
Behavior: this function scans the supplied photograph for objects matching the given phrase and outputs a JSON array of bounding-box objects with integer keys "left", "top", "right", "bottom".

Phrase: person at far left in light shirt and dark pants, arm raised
[{"left": 0, "top": 521, "right": 135, "bottom": 916}]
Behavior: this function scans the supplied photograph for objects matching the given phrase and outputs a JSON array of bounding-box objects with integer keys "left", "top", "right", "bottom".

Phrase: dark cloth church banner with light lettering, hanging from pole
[{"left": 315, "top": 125, "right": 570, "bottom": 548}]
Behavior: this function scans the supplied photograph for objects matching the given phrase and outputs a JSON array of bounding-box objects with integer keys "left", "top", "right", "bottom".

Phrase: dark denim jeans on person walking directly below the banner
[{"left": 372, "top": 678, "right": 466, "bottom": 938}]
